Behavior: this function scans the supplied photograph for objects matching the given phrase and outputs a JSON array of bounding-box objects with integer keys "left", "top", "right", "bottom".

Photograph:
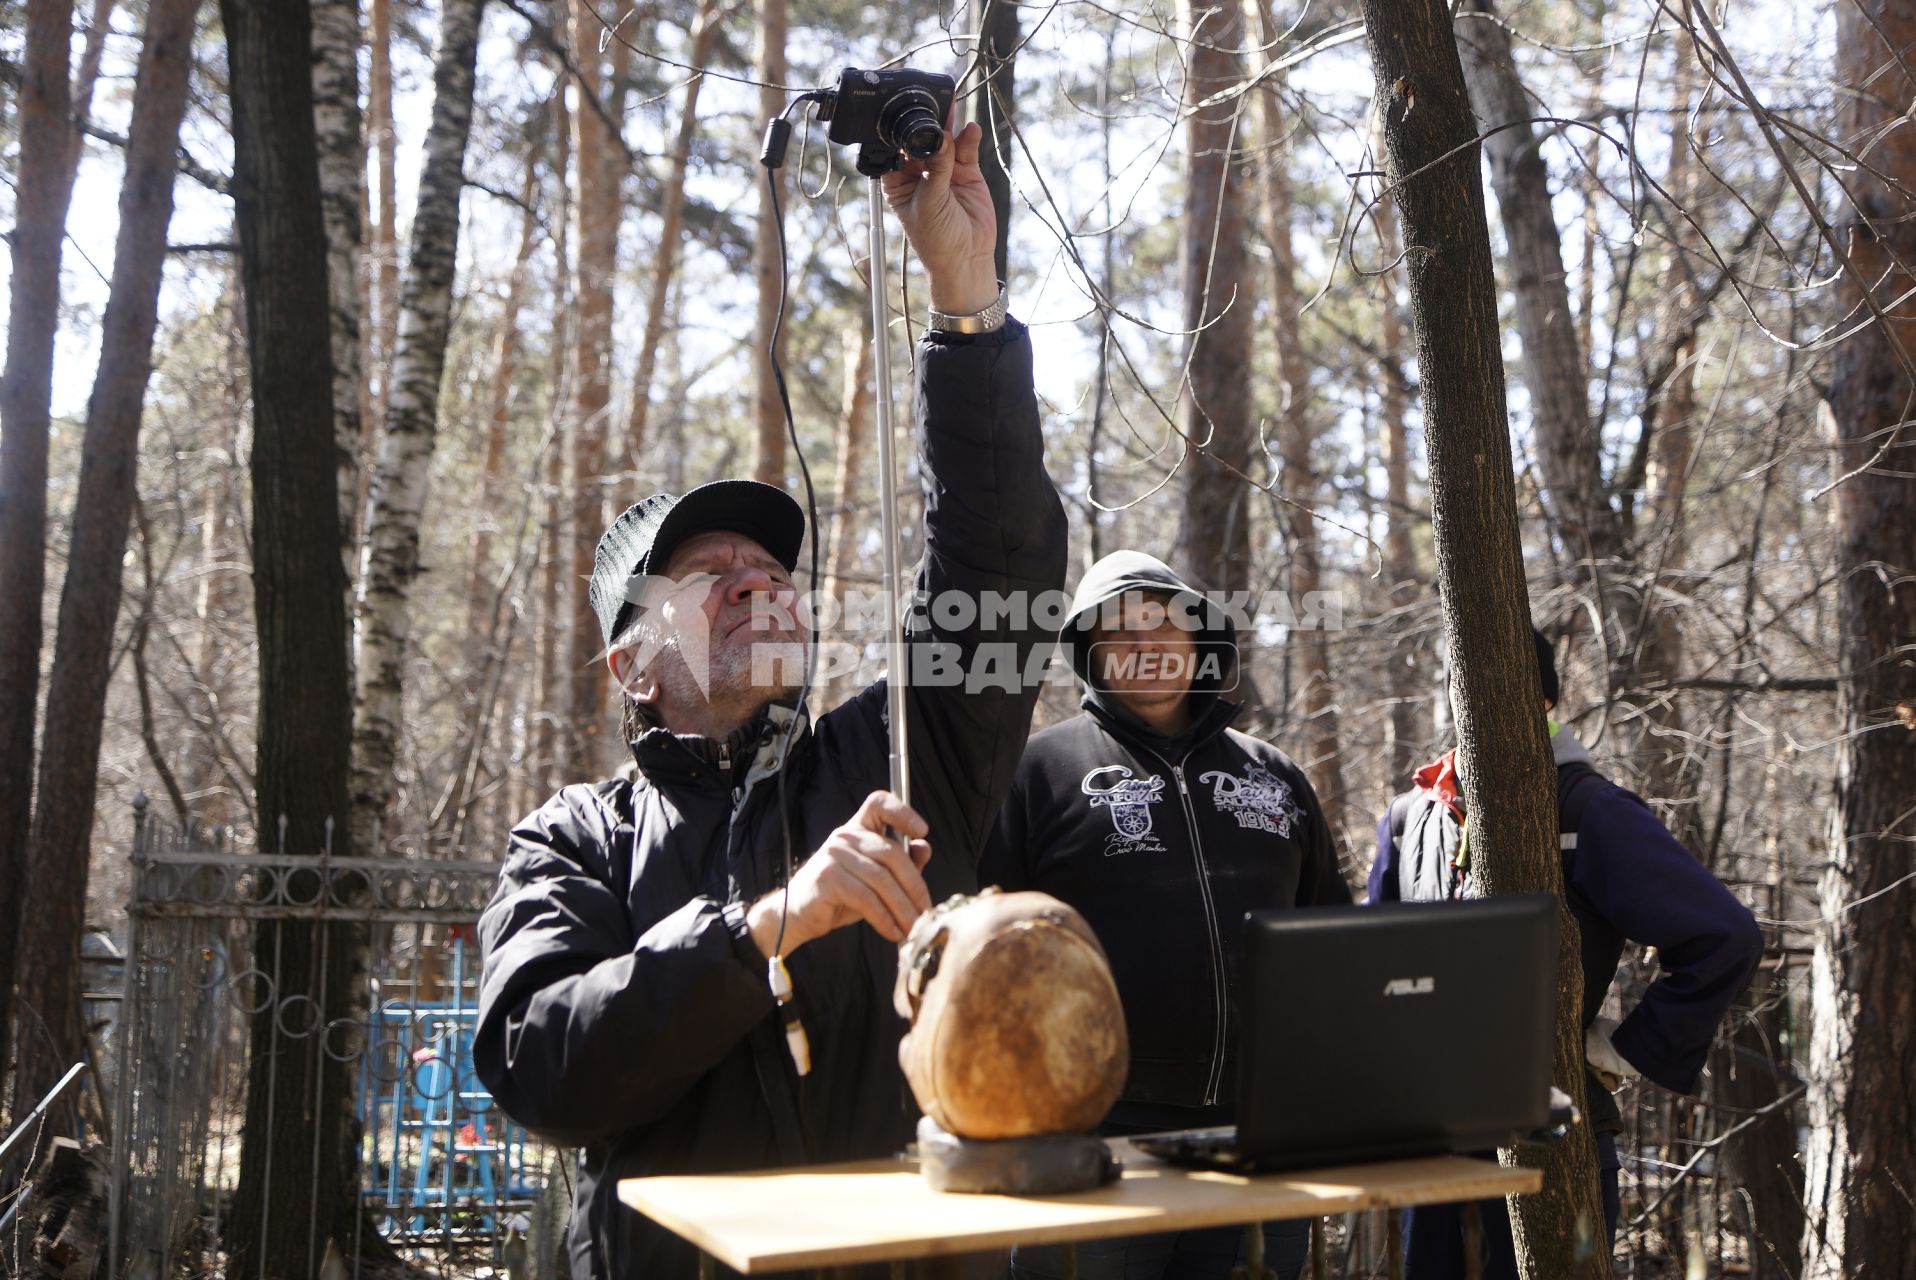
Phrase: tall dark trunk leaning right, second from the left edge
[{"left": 15, "top": 0, "right": 199, "bottom": 1119}]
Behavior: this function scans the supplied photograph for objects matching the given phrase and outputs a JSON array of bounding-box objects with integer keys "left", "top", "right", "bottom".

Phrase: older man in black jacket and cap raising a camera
[{"left": 473, "top": 125, "right": 1065, "bottom": 1276}]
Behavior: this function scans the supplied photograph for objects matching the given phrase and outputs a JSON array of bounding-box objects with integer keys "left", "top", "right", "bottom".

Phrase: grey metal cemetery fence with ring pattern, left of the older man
[{"left": 102, "top": 797, "right": 565, "bottom": 1280}]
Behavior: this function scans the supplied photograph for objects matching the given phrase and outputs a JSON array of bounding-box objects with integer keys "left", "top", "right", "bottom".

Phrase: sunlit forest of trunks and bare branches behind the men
[{"left": 0, "top": 0, "right": 1916, "bottom": 1276}]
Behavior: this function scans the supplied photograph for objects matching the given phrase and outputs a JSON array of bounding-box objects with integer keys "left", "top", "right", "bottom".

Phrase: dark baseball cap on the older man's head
[{"left": 586, "top": 479, "right": 805, "bottom": 646}]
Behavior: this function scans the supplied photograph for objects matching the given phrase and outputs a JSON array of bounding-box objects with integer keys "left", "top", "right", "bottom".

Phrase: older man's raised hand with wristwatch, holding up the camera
[{"left": 881, "top": 123, "right": 998, "bottom": 316}]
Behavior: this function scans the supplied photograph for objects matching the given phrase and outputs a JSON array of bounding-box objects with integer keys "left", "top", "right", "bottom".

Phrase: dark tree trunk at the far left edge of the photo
[{"left": 0, "top": 0, "right": 75, "bottom": 1109}]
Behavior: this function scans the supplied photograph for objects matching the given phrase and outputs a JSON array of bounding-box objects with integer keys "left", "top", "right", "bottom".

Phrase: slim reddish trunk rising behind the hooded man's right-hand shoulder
[{"left": 1234, "top": 0, "right": 1345, "bottom": 834}]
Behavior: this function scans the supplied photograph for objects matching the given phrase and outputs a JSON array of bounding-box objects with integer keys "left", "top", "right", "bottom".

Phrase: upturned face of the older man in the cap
[{"left": 613, "top": 533, "right": 809, "bottom": 732}]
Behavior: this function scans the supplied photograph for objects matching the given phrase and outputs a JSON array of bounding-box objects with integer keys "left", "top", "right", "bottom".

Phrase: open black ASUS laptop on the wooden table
[{"left": 1130, "top": 895, "right": 1558, "bottom": 1173}]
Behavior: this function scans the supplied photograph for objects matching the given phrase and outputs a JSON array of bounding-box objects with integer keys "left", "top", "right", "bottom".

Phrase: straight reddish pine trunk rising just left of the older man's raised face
[{"left": 561, "top": 0, "right": 619, "bottom": 782}]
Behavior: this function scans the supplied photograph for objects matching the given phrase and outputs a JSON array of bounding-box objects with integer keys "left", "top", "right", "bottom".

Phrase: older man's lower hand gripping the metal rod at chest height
[{"left": 745, "top": 791, "right": 931, "bottom": 956}]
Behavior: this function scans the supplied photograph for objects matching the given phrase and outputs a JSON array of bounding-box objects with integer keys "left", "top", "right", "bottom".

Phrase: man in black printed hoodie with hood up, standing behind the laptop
[{"left": 979, "top": 552, "right": 1351, "bottom": 1280}]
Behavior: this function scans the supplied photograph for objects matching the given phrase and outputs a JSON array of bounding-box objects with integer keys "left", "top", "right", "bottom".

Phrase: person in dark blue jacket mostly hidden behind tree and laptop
[{"left": 1370, "top": 632, "right": 1763, "bottom": 1280}]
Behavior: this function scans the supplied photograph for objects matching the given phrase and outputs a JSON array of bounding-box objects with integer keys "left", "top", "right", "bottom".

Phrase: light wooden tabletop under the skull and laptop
[{"left": 619, "top": 1138, "right": 1542, "bottom": 1274}]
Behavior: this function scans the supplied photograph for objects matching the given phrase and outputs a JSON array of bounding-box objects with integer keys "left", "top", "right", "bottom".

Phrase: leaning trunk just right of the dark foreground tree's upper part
[{"left": 1456, "top": 0, "right": 1623, "bottom": 563}]
